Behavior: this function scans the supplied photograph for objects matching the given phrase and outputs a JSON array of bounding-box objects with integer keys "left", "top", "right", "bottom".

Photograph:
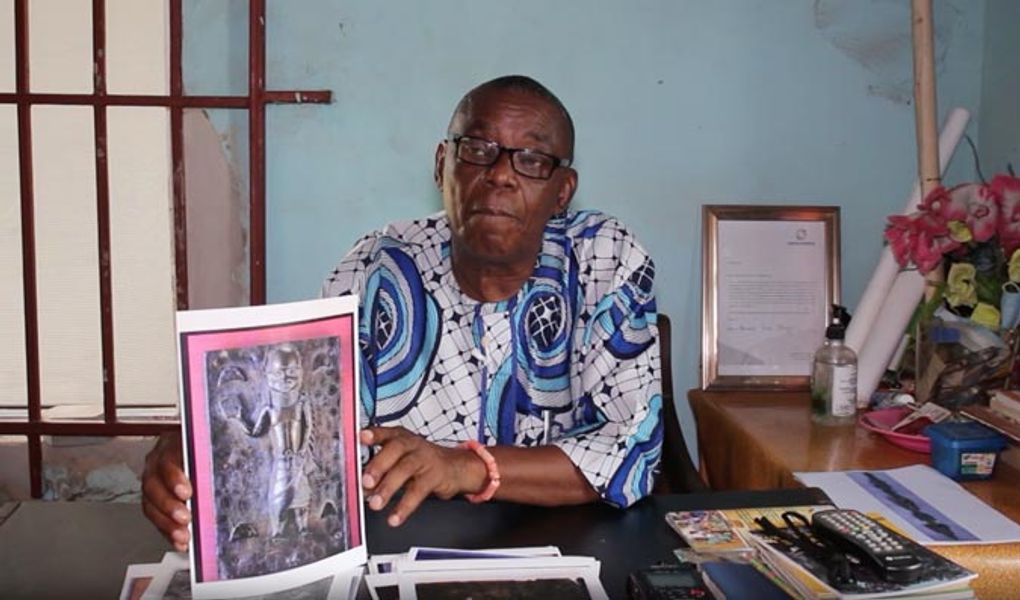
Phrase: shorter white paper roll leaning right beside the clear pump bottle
[{"left": 857, "top": 270, "right": 924, "bottom": 408}]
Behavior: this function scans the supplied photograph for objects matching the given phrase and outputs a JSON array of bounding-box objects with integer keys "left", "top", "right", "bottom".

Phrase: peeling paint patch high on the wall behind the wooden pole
[{"left": 814, "top": 0, "right": 962, "bottom": 104}]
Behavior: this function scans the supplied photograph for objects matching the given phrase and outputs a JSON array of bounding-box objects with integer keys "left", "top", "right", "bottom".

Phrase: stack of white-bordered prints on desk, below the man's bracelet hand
[{"left": 365, "top": 546, "right": 608, "bottom": 600}]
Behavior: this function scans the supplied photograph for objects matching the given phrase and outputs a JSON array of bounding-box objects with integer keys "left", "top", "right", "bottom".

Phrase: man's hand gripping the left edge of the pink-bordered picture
[{"left": 142, "top": 434, "right": 192, "bottom": 552}]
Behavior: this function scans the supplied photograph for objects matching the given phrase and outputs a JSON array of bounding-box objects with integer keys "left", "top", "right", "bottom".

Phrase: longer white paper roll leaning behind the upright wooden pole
[{"left": 846, "top": 107, "right": 970, "bottom": 357}]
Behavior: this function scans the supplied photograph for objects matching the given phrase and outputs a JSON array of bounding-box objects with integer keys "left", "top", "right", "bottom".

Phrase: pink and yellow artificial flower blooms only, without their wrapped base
[{"left": 885, "top": 176, "right": 1020, "bottom": 332}]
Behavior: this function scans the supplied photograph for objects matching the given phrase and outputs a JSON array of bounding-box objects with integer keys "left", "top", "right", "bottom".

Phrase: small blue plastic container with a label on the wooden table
[{"left": 924, "top": 421, "right": 1007, "bottom": 481}]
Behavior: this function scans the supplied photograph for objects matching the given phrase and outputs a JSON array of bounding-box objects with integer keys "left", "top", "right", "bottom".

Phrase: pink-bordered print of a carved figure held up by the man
[{"left": 177, "top": 297, "right": 367, "bottom": 598}]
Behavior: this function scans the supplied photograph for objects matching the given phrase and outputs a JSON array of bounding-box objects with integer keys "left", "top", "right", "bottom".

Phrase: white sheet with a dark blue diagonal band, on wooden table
[{"left": 794, "top": 464, "right": 1020, "bottom": 545}]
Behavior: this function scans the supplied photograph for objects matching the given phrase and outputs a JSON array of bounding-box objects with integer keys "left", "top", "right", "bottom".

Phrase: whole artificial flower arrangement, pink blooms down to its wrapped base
[{"left": 885, "top": 176, "right": 1020, "bottom": 407}]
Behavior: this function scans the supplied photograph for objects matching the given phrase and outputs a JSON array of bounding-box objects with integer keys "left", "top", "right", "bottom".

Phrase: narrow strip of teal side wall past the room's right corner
[{"left": 980, "top": 0, "right": 1020, "bottom": 178}]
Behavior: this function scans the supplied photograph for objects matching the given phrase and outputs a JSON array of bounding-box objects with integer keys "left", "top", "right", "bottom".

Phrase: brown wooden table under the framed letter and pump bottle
[{"left": 687, "top": 390, "right": 1020, "bottom": 598}]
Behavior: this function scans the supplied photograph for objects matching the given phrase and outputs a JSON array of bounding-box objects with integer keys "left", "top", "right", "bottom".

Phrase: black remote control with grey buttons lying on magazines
[{"left": 811, "top": 510, "right": 922, "bottom": 584}]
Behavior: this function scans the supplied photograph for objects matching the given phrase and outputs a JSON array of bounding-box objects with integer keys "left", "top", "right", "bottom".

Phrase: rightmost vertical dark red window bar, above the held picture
[{"left": 248, "top": 0, "right": 265, "bottom": 305}]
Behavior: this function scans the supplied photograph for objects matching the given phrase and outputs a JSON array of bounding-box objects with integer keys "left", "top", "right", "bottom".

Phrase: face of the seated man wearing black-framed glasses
[{"left": 436, "top": 89, "right": 577, "bottom": 265}]
